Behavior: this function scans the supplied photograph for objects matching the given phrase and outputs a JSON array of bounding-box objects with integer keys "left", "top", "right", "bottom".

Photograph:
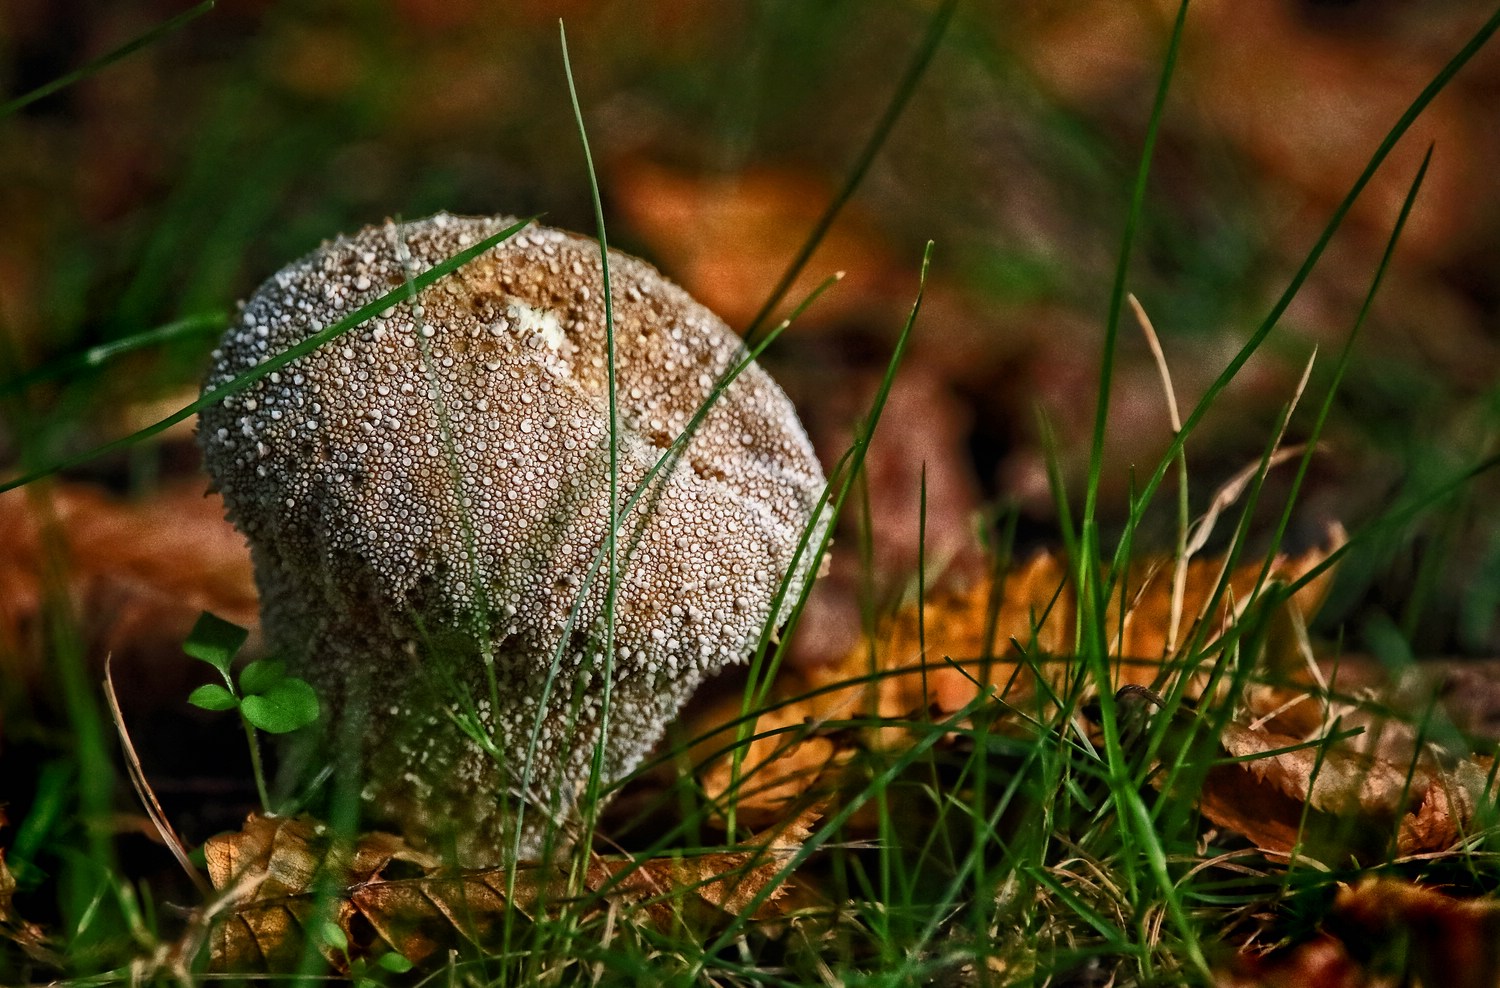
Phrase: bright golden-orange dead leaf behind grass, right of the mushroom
[{"left": 690, "top": 532, "right": 1343, "bottom": 825}]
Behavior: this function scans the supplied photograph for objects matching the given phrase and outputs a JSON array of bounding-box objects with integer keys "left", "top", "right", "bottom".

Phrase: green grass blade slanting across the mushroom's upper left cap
[{"left": 0, "top": 217, "right": 534, "bottom": 493}]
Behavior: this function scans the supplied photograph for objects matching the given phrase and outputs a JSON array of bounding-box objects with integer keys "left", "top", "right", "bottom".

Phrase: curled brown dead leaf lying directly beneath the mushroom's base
[{"left": 206, "top": 807, "right": 822, "bottom": 972}]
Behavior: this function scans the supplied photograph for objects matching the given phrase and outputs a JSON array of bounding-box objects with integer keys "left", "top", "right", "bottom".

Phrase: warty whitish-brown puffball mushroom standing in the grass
[{"left": 198, "top": 213, "right": 825, "bottom": 867}]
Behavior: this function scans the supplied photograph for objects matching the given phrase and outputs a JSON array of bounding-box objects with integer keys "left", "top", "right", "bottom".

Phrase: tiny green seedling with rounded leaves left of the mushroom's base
[{"left": 183, "top": 612, "right": 320, "bottom": 813}]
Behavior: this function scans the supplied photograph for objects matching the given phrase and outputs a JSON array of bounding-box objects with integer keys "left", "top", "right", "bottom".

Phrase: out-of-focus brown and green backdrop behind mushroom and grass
[{"left": 0, "top": 0, "right": 1500, "bottom": 785}]
